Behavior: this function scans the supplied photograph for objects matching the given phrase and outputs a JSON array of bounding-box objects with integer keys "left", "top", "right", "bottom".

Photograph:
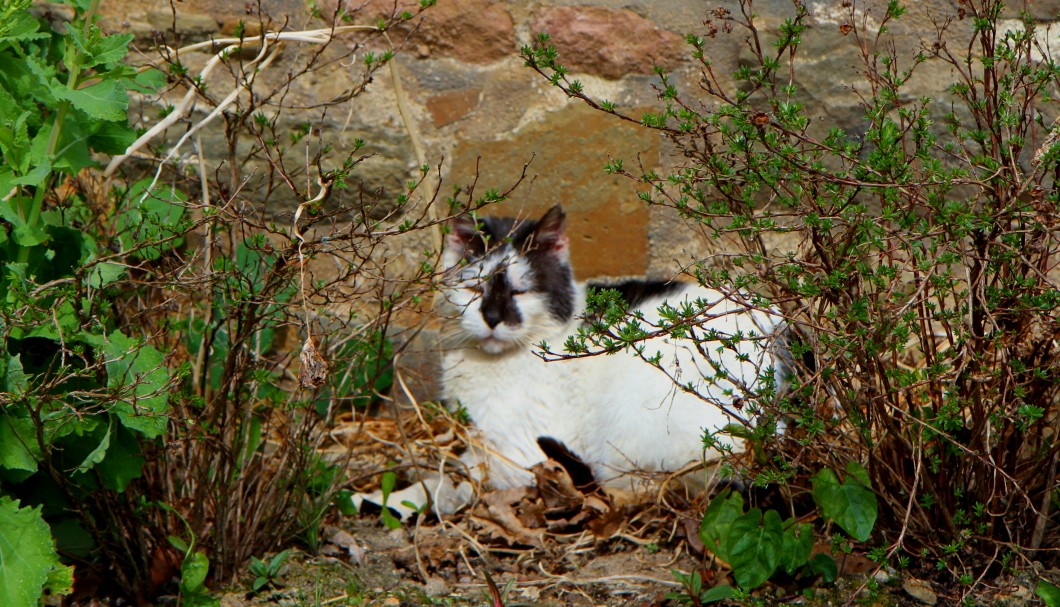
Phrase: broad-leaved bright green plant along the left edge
[{"left": 0, "top": 2, "right": 175, "bottom": 604}]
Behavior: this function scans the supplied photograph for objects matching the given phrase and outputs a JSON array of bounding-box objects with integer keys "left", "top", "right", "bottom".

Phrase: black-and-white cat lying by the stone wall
[{"left": 439, "top": 206, "right": 782, "bottom": 488}]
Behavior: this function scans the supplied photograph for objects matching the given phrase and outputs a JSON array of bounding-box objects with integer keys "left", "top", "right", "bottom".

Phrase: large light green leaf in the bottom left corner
[{"left": 0, "top": 496, "right": 73, "bottom": 607}]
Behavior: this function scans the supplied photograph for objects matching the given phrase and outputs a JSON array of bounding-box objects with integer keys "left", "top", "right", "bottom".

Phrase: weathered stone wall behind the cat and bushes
[{"left": 93, "top": 0, "right": 1060, "bottom": 398}]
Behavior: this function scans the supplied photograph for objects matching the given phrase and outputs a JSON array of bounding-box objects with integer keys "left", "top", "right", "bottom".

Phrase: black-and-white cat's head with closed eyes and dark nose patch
[{"left": 442, "top": 206, "right": 575, "bottom": 354}]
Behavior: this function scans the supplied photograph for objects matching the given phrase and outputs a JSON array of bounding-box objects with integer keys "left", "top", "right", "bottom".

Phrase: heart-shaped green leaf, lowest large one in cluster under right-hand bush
[{"left": 728, "top": 508, "right": 784, "bottom": 590}]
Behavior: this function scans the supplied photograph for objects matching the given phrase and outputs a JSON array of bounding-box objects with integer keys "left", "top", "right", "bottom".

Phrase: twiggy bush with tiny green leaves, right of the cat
[{"left": 523, "top": 0, "right": 1060, "bottom": 594}]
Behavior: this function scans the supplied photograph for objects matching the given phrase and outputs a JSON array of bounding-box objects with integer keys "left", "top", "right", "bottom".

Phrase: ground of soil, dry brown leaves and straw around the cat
[{"left": 208, "top": 411, "right": 1060, "bottom": 607}]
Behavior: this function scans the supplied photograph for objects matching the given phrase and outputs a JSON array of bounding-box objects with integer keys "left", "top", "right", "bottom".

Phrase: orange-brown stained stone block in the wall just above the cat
[{"left": 443, "top": 105, "right": 659, "bottom": 279}]
